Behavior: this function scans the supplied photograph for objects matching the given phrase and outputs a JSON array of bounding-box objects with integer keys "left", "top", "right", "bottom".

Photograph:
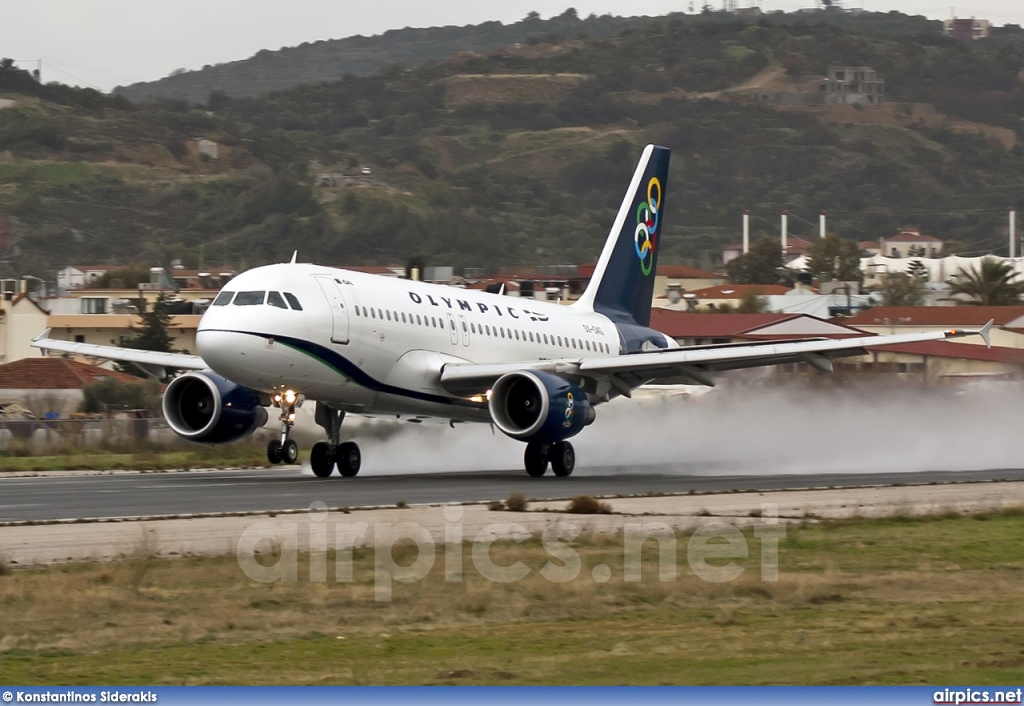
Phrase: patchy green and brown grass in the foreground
[{"left": 0, "top": 513, "right": 1024, "bottom": 684}]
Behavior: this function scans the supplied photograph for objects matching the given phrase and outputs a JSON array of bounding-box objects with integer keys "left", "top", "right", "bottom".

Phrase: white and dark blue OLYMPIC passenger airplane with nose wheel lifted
[{"left": 33, "top": 144, "right": 991, "bottom": 477}]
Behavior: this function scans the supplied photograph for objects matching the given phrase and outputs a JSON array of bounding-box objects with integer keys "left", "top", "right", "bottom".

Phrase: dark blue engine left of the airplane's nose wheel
[{"left": 163, "top": 371, "right": 267, "bottom": 444}]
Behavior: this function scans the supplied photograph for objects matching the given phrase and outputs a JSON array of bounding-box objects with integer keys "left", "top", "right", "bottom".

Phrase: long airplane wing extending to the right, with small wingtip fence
[{"left": 440, "top": 322, "right": 992, "bottom": 397}]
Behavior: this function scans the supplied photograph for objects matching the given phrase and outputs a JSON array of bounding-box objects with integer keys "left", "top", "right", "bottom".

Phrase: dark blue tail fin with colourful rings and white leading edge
[{"left": 573, "top": 144, "right": 671, "bottom": 326}]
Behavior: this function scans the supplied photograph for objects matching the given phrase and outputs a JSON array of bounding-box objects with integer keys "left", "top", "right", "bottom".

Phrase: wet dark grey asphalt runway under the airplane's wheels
[{"left": 6, "top": 467, "right": 1024, "bottom": 522}]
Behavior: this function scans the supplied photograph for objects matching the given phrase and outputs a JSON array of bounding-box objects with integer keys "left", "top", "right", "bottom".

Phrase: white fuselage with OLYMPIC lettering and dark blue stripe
[{"left": 197, "top": 264, "right": 621, "bottom": 420}]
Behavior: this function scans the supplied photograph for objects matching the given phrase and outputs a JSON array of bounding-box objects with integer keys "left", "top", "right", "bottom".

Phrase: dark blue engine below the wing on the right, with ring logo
[{"left": 487, "top": 370, "right": 594, "bottom": 444}]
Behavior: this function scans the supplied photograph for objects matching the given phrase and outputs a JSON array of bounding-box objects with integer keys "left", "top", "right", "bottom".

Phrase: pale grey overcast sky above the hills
[{"left": 0, "top": 0, "right": 1024, "bottom": 91}]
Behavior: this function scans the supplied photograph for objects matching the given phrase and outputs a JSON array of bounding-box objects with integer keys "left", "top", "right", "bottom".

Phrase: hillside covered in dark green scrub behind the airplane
[{"left": 0, "top": 12, "right": 1024, "bottom": 276}]
